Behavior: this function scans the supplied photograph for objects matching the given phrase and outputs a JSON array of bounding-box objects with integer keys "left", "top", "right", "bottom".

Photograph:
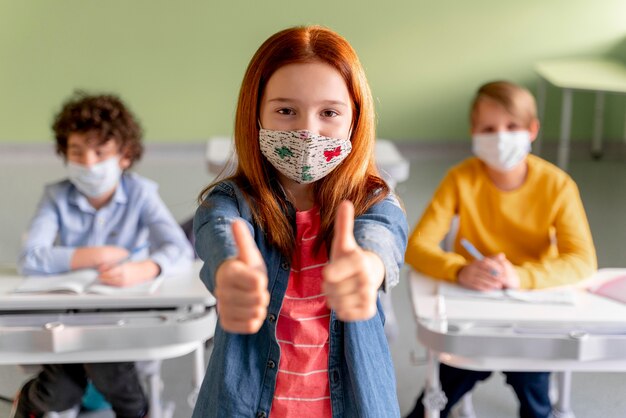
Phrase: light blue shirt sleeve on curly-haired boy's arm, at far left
[{"left": 18, "top": 188, "right": 74, "bottom": 275}]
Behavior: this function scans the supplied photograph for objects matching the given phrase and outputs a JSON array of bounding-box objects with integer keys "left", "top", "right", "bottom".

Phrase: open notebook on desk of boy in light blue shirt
[{"left": 13, "top": 269, "right": 163, "bottom": 296}]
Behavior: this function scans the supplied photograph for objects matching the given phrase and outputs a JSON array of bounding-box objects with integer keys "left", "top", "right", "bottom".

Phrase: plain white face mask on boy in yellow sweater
[{"left": 472, "top": 131, "right": 531, "bottom": 171}]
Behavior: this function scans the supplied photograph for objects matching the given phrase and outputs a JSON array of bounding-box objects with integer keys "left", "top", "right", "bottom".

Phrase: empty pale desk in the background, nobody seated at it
[{"left": 535, "top": 59, "right": 626, "bottom": 170}]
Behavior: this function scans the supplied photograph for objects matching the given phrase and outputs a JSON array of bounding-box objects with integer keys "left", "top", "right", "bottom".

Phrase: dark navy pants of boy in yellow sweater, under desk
[{"left": 406, "top": 364, "right": 552, "bottom": 418}]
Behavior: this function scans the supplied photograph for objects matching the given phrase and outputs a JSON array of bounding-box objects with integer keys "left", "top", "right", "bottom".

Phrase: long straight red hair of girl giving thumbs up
[{"left": 200, "top": 26, "right": 389, "bottom": 256}]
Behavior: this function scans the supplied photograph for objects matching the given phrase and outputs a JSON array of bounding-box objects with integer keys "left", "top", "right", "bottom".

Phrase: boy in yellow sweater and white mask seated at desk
[{"left": 406, "top": 81, "right": 597, "bottom": 418}]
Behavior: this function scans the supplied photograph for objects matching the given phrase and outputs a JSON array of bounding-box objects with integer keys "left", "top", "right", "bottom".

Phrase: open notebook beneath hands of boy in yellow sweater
[{"left": 438, "top": 282, "right": 576, "bottom": 305}]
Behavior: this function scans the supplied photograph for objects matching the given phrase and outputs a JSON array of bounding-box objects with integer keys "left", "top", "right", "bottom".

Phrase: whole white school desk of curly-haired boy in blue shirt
[{"left": 0, "top": 262, "right": 217, "bottom": 418}]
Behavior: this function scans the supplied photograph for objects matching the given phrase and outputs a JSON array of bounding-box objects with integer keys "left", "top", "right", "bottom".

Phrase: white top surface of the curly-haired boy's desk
[{"left": 0, "top": 261, "right": 215, "bottom": 311}]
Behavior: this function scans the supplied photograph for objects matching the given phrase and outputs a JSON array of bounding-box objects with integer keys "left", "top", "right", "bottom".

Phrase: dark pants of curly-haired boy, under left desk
[{"left": 16, "top": 363, "right": 148, "bottom": 418}]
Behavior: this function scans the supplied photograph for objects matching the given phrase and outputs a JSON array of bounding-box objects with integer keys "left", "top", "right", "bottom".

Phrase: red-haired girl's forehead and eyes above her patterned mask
[{"left": 260, "top": 62, "right": 352, "bottom": 139}]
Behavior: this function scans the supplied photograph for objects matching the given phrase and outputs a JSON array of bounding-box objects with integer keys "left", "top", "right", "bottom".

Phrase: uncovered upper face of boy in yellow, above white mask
[{"left": 471, "top": 98, "right": 539, "bottom": 141}]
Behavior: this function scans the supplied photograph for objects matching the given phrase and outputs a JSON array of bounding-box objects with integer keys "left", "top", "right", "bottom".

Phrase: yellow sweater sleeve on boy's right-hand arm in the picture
[{"left": 515, "top": 180, "right": 598, "bottom": 289}]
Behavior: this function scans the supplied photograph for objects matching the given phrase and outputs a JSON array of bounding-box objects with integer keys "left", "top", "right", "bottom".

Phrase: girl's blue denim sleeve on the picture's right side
[{"left": 354, "top": 194, "right": 408, "bottom": 291}]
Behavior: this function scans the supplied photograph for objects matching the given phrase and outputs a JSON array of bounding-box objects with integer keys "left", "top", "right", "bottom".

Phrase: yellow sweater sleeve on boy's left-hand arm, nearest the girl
[{"left": 406, "top": 173, "right": 467, "bottom": 282}]
